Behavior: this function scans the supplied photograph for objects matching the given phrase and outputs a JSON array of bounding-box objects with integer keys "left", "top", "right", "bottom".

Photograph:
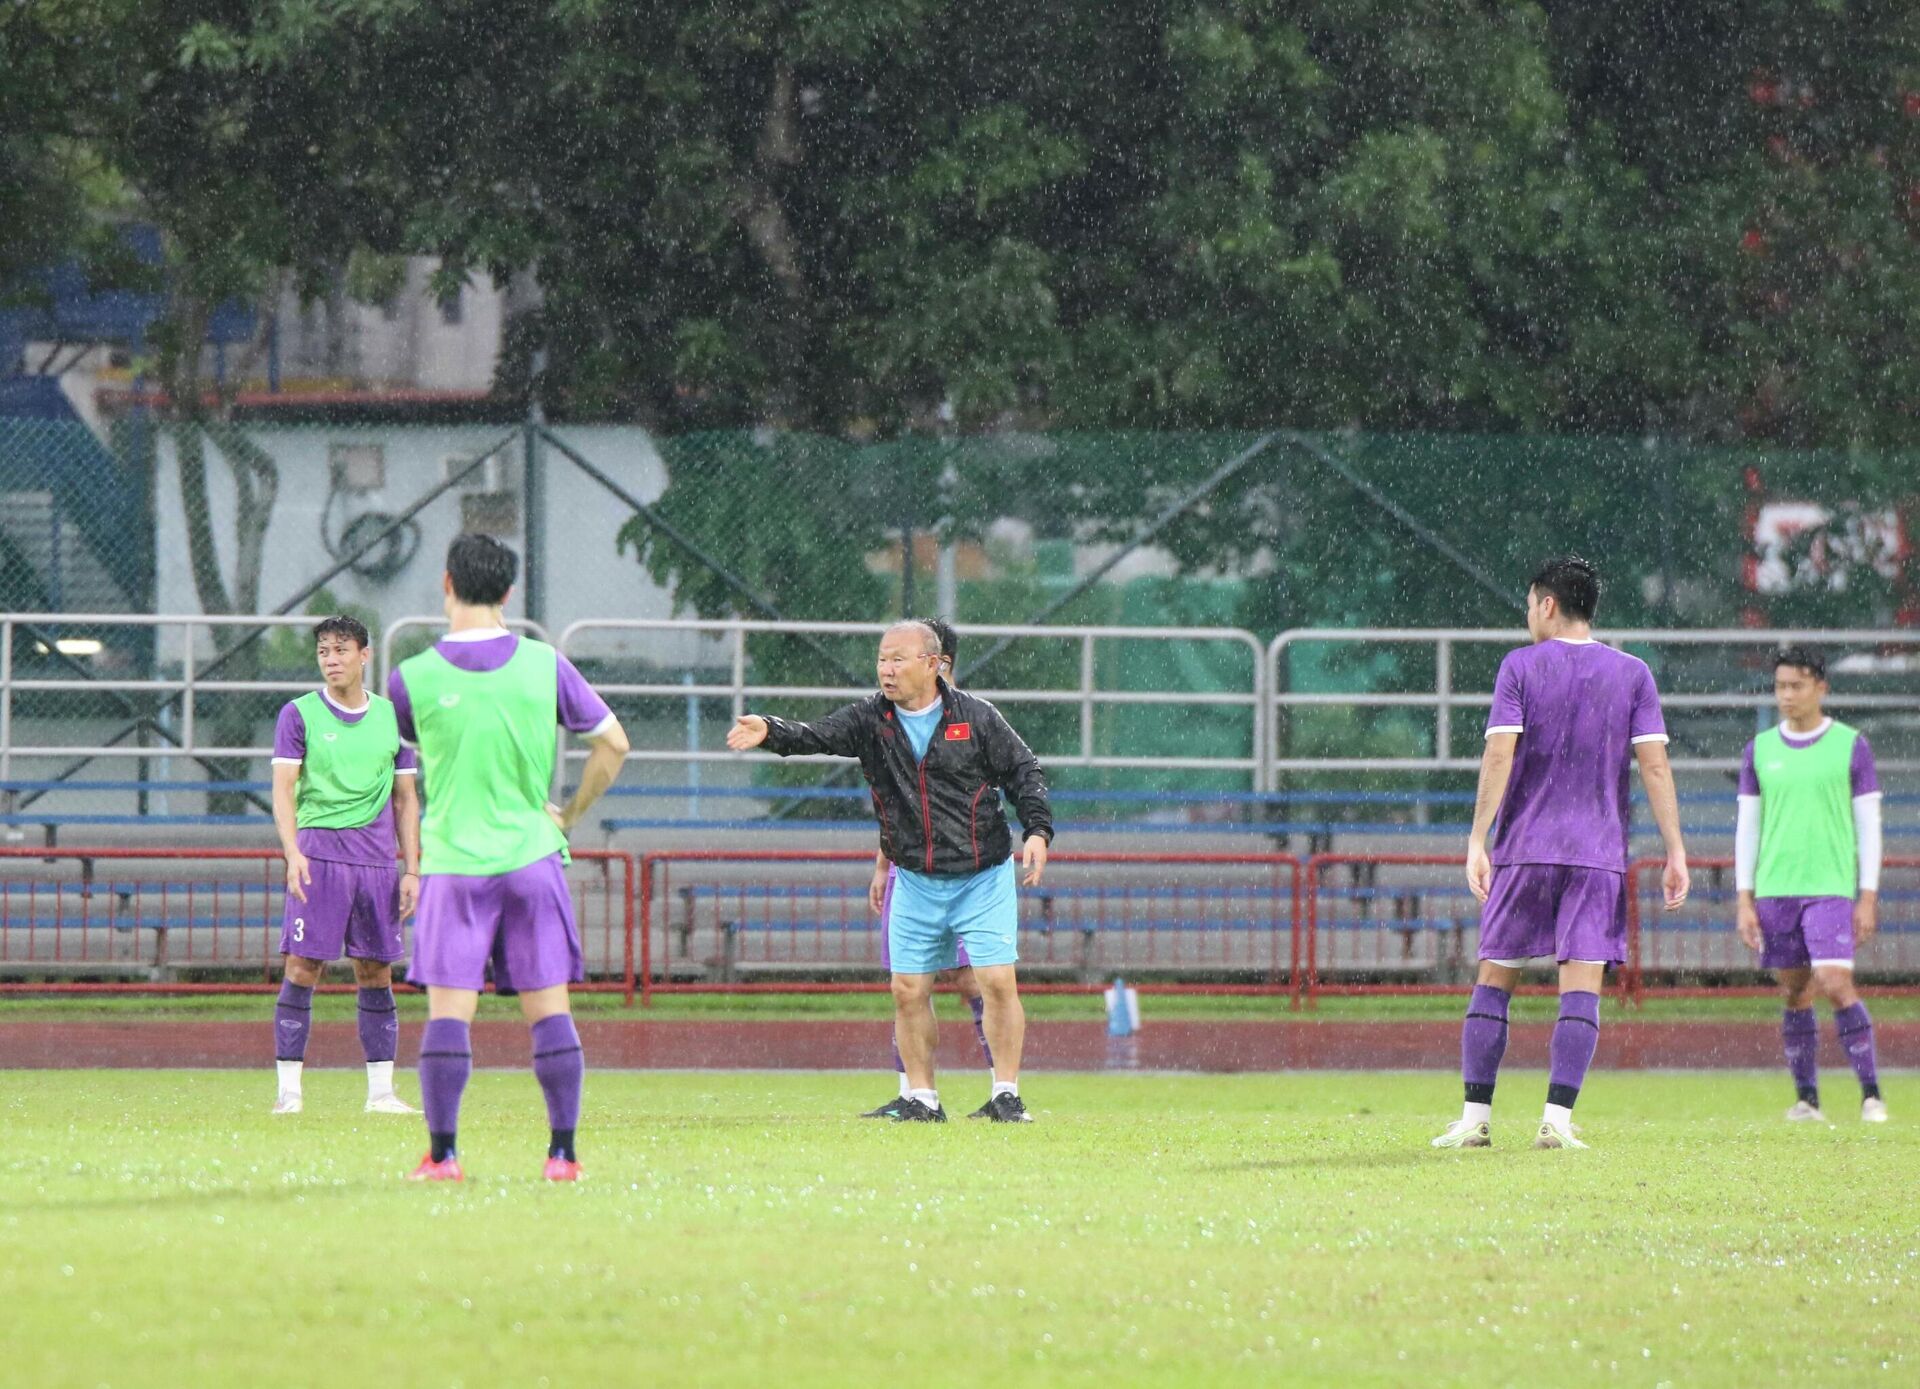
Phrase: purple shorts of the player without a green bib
[{"left": 1480, "top": 863, "right": 1626, "bottom": 964}]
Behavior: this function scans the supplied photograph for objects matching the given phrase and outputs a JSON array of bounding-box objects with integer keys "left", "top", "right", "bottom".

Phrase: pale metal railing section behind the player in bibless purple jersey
[{"left": 1267, "top": 626, "right": 1920, "bottom": 776}]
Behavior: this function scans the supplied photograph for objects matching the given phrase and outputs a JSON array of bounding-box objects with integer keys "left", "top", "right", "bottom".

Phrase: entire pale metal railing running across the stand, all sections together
[{"left": 0, "top": 613, "right": 1920, "bottom": 793}]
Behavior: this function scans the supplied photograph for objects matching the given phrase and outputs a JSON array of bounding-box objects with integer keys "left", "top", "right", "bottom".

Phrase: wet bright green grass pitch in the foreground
[{"left": 0, "top": 1072, "right": 1920, "bottom": 1389}]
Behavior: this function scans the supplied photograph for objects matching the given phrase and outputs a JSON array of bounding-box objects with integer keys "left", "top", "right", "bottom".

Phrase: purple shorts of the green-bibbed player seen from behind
[{"left": 407, "top": 853, "right": 588, "bottom": 993}]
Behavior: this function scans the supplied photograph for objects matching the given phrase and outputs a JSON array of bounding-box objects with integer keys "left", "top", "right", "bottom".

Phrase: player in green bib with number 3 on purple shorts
[{"left": 273, "top": 617, "right": 420, "bottom": 1114}]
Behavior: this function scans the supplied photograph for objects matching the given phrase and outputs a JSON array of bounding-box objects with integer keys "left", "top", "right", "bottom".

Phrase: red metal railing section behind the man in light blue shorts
[{"left": 639, "top": 851, "right": 1300, "bottom": 1003}]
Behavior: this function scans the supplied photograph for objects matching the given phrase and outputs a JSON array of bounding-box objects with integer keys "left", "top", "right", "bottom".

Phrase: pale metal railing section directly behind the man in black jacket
[{"left": 559, "top": 619, "right": 1269, "bottom": 790}]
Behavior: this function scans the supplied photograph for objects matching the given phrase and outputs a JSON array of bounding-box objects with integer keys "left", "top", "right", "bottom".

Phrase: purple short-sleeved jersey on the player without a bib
[{"left": 1486, "top": 638, "right": 1667, "bottom": 872}]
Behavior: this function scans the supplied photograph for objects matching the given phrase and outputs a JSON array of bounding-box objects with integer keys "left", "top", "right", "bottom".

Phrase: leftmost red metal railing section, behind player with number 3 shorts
[{"left": 0, "top": 847, "right": 637, "bottom": 993}]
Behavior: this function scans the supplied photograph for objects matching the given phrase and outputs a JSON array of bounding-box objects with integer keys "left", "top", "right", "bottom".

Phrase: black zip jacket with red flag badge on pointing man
[{"left": 762, "top": 680, "right": 1054, "bottom": 878}]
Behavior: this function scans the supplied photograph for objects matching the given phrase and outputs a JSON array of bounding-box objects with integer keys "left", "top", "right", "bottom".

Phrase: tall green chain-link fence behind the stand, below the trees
[{"left": 0, "top": 415, "right": 1920, "bottom": 813}]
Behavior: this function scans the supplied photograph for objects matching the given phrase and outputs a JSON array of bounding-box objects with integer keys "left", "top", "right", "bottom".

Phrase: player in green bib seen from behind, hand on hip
[{"left": 388, "top": 534, "right": 628, "bottom": 1182}]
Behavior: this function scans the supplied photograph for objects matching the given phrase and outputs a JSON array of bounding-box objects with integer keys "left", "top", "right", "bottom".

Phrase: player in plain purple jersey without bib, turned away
[{"left": 1432, "top": 557, "right": 1690, "bottom": 1149}]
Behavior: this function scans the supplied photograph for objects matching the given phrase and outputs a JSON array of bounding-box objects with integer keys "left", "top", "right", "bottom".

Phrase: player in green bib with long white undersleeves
[{"left": 1734, "top": 646, "right": 1887, "bottom": 1124}]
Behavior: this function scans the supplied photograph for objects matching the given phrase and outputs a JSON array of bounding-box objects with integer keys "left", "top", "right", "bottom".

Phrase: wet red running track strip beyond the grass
[{"left": 0, "top": 1009, "right": 1920, "bottom": 1072}]
